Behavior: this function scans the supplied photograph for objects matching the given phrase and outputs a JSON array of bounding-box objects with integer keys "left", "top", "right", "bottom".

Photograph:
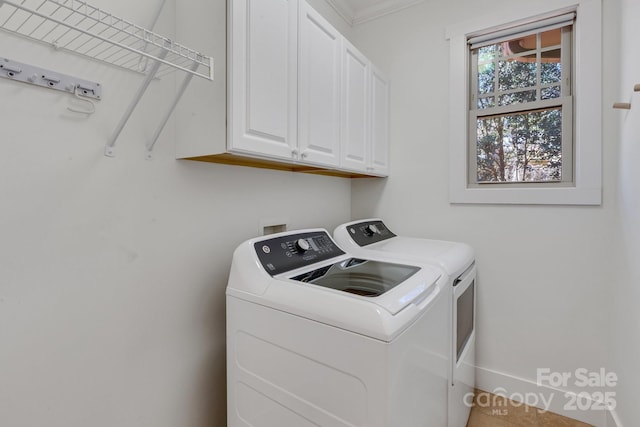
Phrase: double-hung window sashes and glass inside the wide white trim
[{"left": 469, "top": 18, "right": 573, "bottom": 185}]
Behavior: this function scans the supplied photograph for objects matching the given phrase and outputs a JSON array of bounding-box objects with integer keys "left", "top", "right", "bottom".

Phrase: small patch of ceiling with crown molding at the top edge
[{"left": 326, "top": 0, "right": 425, "bottom": 26}]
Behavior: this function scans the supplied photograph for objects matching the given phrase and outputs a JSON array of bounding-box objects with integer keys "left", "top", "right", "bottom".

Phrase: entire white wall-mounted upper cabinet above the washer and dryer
[{"left": 176, "top": 0, "right": 389, "bottom": 177}]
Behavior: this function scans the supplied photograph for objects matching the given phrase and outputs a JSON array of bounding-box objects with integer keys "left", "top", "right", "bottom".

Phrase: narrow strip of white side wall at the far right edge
[{"left": 611, "top": 0, "right": 640, "bottom": 426}]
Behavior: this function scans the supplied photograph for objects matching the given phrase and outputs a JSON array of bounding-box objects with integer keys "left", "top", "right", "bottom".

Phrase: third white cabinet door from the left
[{"left": 341, "top": 40, "right": 370, "bottom": 171}]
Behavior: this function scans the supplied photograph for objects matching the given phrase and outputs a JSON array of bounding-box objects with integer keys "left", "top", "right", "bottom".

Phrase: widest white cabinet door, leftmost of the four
[{"left": 228, "top": 0, "right": 298, "bottom": 159}]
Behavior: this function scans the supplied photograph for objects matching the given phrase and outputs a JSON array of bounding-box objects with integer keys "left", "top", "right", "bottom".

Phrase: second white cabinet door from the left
[{"left": 298, "top": 1, "right": 342, "bottom": 166}]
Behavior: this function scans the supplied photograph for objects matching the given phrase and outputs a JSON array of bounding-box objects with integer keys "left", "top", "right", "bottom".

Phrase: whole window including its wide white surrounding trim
[{"left": 447, "top": 0, "right": 601, "bottom": 204}]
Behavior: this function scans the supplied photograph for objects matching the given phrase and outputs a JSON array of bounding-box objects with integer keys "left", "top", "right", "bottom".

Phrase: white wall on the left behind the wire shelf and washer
[{"left": 0, "top": 0, "right": 351, "bottom": 427}]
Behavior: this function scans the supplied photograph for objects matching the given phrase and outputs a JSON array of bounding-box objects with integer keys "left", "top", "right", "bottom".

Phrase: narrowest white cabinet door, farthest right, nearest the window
[{"left": 369, "top": 66, "right": 389, "bottom": 175}]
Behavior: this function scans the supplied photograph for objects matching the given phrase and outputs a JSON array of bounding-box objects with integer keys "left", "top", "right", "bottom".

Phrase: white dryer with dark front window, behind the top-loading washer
[{"left": 333, "top": 218, "right": 476, "bottom": 427}]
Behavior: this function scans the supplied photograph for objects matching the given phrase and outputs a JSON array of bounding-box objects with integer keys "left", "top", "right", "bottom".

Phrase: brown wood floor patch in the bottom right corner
[{"left": 467, "top": 390, "right": 593, "bottom": 427}]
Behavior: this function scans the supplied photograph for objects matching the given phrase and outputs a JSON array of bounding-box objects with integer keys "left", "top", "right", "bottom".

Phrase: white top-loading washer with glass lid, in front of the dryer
[{"left": 226, "top": 229, "right": 450, "bottom": 427}]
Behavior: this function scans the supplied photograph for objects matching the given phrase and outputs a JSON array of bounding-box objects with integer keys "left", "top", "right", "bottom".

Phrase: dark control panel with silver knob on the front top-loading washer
[{"left": 254, "top": 231, "right": 345, "bottom": 276}]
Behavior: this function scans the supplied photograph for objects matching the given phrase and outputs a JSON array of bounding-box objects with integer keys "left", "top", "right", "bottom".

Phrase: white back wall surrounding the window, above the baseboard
[{"left": 352, "top": 0, "right": 624, "bottom": 422}]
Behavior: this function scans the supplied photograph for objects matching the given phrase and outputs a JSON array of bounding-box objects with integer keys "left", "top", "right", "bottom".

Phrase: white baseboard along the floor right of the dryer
[{"left": 476, "top": 367, "right": 623, "bottom": 427}]
